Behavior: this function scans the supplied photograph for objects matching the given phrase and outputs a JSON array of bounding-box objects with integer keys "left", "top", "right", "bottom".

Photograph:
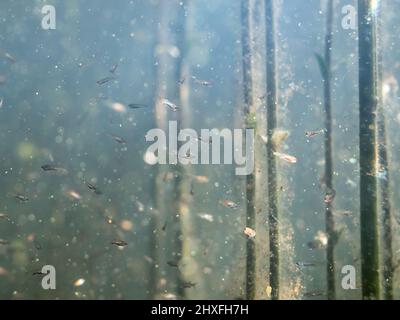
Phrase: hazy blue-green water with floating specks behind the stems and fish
[{"left": 0, "top": 0, "right": 400, "bottom": 299}]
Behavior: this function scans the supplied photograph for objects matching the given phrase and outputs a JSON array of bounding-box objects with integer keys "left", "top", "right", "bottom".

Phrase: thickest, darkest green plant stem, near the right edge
[{"left": 358, "top": 0, "right": 380, "bottom": 299}]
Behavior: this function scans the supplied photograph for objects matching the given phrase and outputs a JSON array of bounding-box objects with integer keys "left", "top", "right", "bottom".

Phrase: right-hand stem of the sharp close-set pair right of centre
[{"left": 265, "top": 0, "right": 279, "bottom": 300}]
